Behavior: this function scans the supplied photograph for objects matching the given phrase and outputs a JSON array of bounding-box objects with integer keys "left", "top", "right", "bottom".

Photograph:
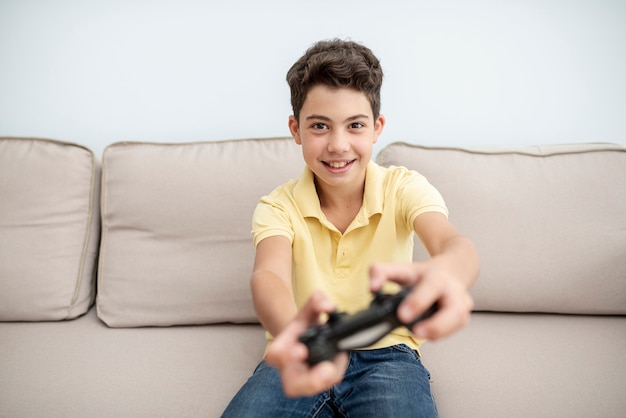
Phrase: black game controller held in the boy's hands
[{"left": 299, "top": 288, "right": 439, "bottom": 365}]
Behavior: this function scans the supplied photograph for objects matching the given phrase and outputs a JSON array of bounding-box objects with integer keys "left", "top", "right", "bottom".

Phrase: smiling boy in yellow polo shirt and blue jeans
[{"left": 224, "top": 40, "right": 478, "bottom": 417}]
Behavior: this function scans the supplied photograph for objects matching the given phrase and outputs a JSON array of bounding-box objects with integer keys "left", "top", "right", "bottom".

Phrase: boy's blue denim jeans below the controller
[{"left": 222, "top": 345, "right": 437, "bottom": 418}]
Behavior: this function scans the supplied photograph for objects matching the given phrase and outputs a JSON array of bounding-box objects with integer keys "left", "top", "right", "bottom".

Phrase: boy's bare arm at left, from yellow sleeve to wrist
[{"left": 250, "top": 236, "right": 298, "bottom": 336}]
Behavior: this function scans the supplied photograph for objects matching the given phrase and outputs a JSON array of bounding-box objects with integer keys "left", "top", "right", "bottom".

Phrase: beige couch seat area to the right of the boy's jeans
[{"left": 422, "top": 313, "right": 626, "bottom": 418}]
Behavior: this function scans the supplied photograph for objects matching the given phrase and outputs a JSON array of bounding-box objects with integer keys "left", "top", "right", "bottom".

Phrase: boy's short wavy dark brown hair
[{"left": 287, "top": 39, "right": 383, "bottom": 120}]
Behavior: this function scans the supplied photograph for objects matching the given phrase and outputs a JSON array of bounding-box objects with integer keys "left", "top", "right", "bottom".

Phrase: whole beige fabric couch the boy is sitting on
[{"left": 0, "top": 138, "right": 626, "bottom": 418}]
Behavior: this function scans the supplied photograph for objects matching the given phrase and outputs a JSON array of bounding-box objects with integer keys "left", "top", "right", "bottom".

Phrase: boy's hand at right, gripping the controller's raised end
[{"left": 370, "top": 260, "right": 474, "bottom": 340}]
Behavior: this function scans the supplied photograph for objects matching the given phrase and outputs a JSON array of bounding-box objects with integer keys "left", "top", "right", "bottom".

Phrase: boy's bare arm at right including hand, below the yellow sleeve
[{"left": 370, "top": 212, "right": 479, "bottom": 339}]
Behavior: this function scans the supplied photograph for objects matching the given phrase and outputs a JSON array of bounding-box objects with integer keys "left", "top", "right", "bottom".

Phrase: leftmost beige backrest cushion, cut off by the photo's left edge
[{"left": 0, "top": 138, "right": 100, "bottom": 321}]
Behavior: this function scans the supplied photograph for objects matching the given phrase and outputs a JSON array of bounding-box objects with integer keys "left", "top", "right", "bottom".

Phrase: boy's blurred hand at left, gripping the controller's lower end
[{"left": 265, "top": 292, "right": 348, "bottom": 397}]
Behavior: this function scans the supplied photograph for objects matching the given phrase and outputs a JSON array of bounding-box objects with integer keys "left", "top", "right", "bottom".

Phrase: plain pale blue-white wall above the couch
[{"left": 0, "top": 0, "right": 626, "bottom": 158}]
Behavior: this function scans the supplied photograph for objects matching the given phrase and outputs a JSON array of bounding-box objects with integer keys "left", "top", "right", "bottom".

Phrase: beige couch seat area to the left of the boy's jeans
[{"left": 0, "top": 309, "right": 265, "bottom": 418}]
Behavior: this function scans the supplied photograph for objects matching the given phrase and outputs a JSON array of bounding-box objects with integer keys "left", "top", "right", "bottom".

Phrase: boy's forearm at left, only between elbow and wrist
[{"left": 251, "top": 271, "right": 298, "bottom": 336}]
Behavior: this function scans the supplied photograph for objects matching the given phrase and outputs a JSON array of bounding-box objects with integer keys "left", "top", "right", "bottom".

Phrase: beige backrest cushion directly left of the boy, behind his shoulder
[{"left": 97, "top": 138, "right": 304, "bottom": 327}]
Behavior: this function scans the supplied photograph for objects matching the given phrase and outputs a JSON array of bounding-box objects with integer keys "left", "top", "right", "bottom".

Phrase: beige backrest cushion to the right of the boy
[{"left": 378, "top": 143, "right": 626, "bottom": 314}]
